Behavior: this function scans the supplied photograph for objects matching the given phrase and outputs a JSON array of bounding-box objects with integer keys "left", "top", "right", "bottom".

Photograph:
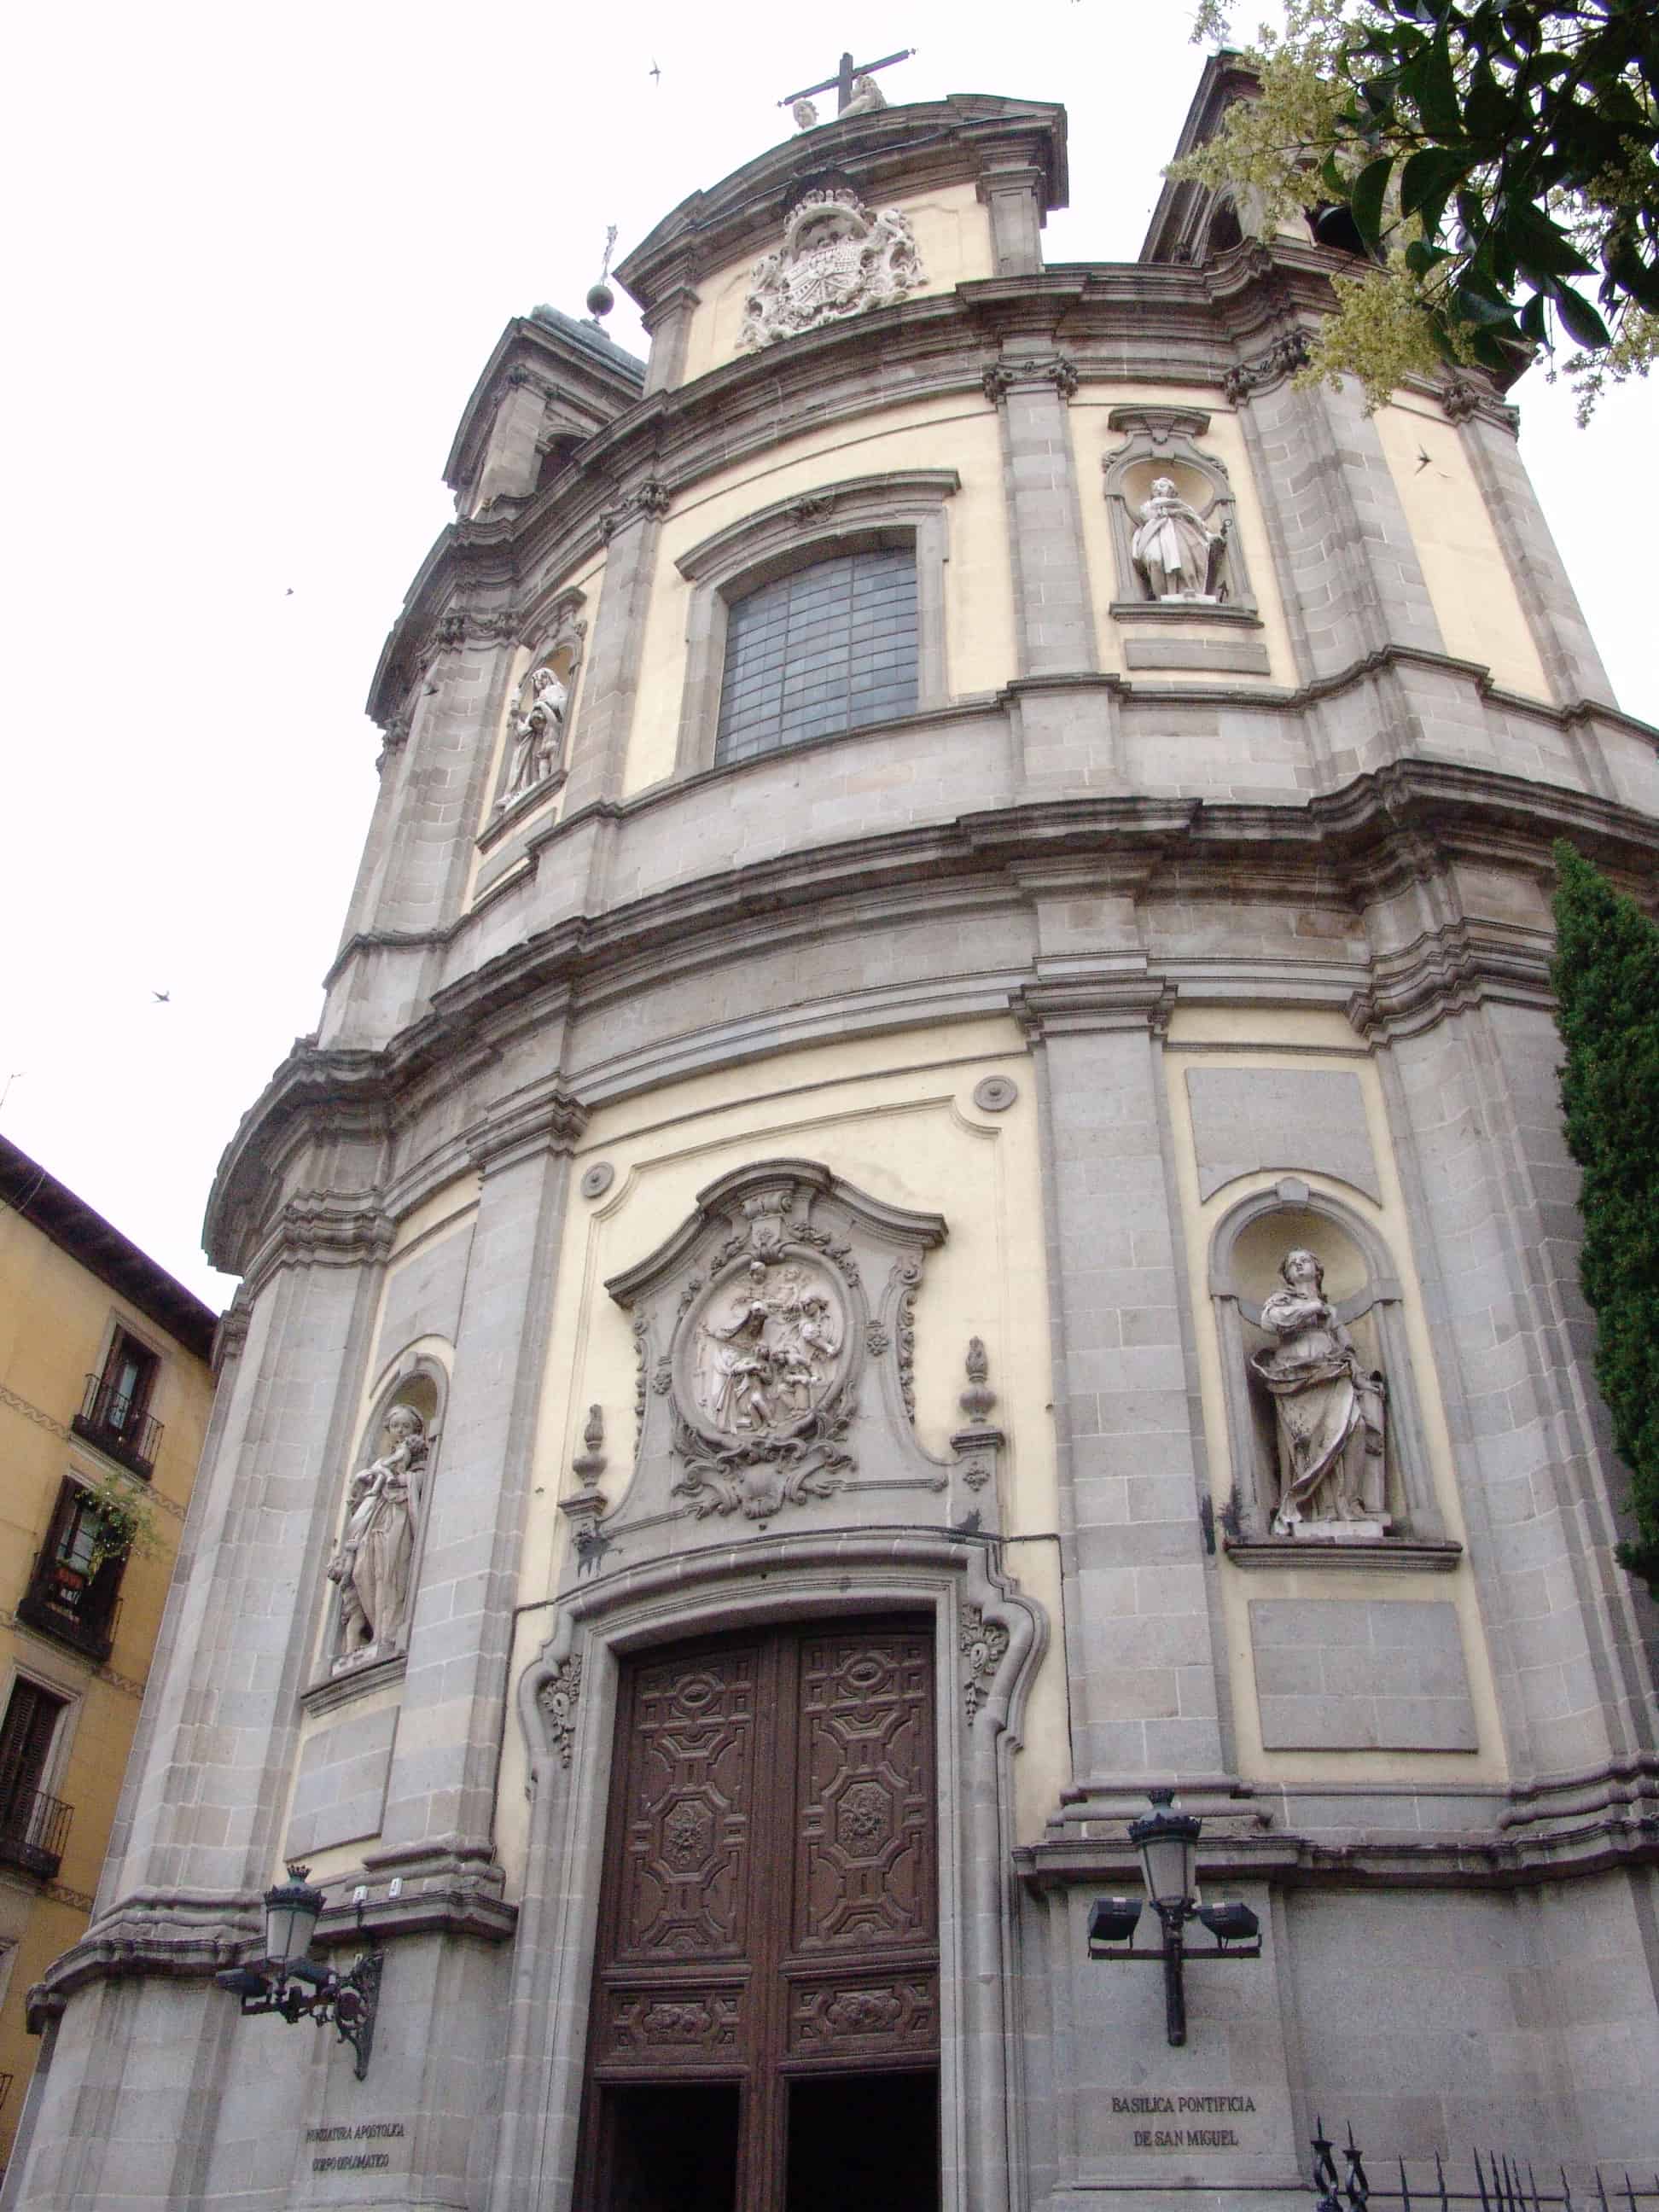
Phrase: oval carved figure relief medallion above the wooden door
[{"left": 692, "top": 1256, "right": 845, "bottom": 1438}]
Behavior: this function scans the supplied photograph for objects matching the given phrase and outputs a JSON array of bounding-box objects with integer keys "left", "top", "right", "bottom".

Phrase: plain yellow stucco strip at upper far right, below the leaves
[{"left": 1374, "top": 393, "right": 1551, "bottom": 699}]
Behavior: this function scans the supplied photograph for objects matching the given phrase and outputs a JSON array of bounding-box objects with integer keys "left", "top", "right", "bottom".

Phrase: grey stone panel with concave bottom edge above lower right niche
[{"left": 1185, "top": 1068, "right": 1382, "bottom": 1203}]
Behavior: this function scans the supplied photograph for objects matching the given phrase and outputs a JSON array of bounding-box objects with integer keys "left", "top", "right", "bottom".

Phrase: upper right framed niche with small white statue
[{"left": 1102, "top": 407, "right": 1254, "bottom": 621}]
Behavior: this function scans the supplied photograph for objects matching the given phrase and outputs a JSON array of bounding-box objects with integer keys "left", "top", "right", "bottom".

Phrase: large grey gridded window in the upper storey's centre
[{"left": 714, "top": 546, "right": 918, "bottom": 765}]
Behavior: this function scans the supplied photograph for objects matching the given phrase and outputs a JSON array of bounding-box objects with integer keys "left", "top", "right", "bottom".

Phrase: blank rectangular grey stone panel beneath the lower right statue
[{"left": 1249, "top": 1597, "right": 1480, "bottom": 1752}]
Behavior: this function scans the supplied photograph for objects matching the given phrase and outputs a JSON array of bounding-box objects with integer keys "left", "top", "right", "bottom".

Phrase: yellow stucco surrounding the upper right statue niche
[{"left": 1066, "top": 385, "right": 1296, "bottom": 688}]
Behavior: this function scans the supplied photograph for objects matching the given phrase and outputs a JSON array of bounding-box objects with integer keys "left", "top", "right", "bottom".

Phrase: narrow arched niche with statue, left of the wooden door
[{"left": 328, "top": 1371, "right": 440, "bottom": 1681}]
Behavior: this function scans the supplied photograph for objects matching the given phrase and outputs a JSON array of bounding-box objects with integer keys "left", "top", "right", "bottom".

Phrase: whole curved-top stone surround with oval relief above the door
[{"left": 575, "top": 1159, "right": 982, "bottom": 1573}]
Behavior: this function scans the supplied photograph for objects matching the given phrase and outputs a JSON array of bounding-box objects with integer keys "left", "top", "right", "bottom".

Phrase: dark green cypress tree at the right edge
[{"left": 1551, "top": 843, "right": 1659, "bottom": 1597}]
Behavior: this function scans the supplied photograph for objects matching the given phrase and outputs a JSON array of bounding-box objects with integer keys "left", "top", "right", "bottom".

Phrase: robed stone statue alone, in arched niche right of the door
[{"left": 1249, "top": 1245, "right": 1389, "bottom": 1537}]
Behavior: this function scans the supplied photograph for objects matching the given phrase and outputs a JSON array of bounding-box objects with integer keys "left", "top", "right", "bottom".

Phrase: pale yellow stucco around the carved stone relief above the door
[{"left": 498, "top": 1020, "right": 1071, "bottom": 1894}]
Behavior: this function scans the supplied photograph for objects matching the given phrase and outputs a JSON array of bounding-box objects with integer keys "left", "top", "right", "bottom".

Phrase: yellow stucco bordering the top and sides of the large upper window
[{"left": 624, "top": 396, "right": 1017, "bottom": 796}]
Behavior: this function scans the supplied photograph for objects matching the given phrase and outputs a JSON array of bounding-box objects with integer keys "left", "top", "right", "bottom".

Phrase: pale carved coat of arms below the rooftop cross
[{"left": 736, "top": 188, "right": 927, "bottom": 352}]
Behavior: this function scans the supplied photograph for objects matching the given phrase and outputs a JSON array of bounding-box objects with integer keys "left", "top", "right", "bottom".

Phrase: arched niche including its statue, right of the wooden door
[{"left": 1210, "top": 1177, "right": 1458, "bottom": 1566}]
